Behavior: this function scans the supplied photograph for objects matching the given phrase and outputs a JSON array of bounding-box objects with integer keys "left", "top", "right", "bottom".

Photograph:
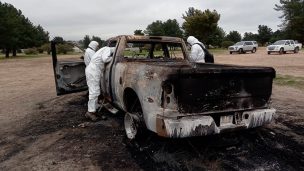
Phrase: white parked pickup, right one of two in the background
[{"left": 267, "top": 40, "right": 302, "bottom": 55}]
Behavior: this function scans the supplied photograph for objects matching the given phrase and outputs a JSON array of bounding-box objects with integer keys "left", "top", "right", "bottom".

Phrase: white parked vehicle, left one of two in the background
[{"left": 228, "top": 41, "right": 258, "bottom": 54}]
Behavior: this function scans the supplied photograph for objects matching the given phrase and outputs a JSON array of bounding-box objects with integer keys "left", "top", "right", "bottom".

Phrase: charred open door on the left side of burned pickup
[{"left": 51, "top": 41, "right": 88, "bottom": 95}]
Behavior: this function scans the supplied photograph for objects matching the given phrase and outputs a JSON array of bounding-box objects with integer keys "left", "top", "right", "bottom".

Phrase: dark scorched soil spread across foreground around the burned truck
[{"left": 0, "top": 93, "right": 304, "bottom": 170}]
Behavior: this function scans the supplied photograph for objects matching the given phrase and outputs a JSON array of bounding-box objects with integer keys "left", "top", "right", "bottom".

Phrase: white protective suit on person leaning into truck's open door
[{"left": 85, "top": 47, "right": 112, "bottom": 113}]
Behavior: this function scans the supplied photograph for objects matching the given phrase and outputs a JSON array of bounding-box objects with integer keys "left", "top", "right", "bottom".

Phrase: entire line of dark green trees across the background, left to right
[{"left": 0, "top": 0, "right": 304, "bottom": 57}]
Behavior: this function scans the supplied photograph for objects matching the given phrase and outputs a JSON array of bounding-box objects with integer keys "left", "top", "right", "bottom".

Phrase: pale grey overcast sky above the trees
[{"left": 1, "top": 0, "right": 281, "bottom": 40}]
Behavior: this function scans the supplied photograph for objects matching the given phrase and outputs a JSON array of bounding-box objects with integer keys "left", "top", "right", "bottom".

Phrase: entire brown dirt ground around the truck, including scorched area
[{"left": 0, "top": 48, "right": 304, "bottom": 171}]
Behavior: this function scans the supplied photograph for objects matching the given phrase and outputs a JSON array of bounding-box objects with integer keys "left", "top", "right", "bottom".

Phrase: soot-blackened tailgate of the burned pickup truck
[{"left": 168, "top": 64, "right": 275, "bottom": 113}]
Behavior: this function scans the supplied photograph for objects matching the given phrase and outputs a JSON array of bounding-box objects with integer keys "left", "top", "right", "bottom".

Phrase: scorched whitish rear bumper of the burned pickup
[{"left": 156, "top": 109, "right": 275, "bottom": 138}]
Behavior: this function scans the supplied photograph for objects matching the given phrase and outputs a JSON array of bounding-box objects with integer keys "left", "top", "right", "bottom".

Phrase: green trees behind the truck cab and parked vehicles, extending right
[{"left": 134, "top": 0, "right": 304, "bottom": 47}]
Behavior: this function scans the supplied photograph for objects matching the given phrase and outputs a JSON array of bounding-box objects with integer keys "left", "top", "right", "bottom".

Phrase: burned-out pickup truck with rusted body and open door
[{"left": 52, "top": 36, "right": 275, "bottom": 139}]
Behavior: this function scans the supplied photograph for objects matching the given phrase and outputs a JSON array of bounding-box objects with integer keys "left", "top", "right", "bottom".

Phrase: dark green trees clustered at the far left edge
[{"left": 0, "top": 2, "right": 49, "bottom": 57}]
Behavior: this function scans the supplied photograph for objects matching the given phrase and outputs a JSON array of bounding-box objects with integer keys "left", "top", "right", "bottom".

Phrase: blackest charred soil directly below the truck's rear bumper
[{"left": 129, "top": 128, "right": 304, "bottom": 170}]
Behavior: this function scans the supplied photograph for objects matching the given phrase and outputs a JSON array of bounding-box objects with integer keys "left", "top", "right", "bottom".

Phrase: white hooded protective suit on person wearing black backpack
[{"left": 187, "top": 36, "right": 205, "bottom": 63}]
